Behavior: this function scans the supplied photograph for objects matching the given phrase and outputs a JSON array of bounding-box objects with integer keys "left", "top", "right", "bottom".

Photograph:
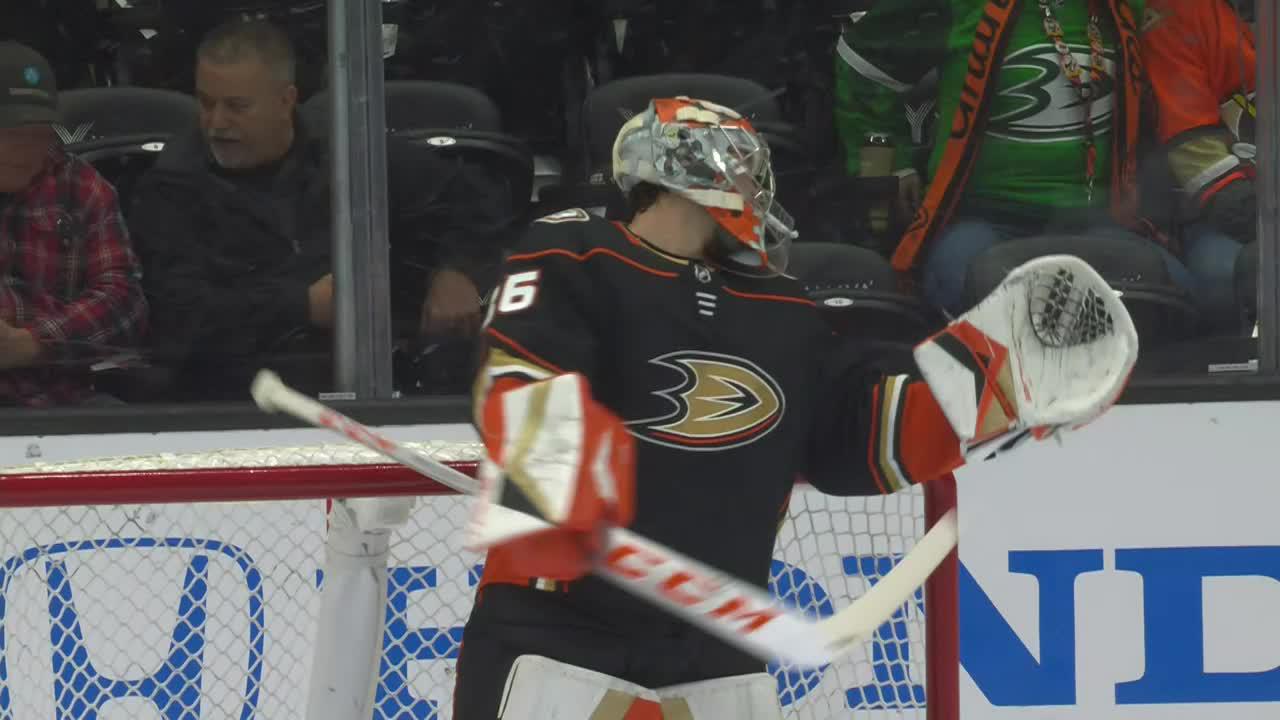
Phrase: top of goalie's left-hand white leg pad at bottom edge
[{"left": 498, "top": 655, "right": 665, "bottom": 720}]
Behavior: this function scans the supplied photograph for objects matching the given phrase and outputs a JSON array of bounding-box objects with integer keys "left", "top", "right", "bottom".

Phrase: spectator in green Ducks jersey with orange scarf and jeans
[{"left": 836, "top": 0, "right": 1190, "bottom": 314}]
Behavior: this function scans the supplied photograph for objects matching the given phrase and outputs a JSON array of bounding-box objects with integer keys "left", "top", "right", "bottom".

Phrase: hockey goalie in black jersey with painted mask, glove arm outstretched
[{"left": 454, "top": 97, "right": 1137, "bottom": 720}]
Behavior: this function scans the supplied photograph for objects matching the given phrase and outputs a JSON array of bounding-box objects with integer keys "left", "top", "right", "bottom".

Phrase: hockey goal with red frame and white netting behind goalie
[{"left": 0, "top": 443, "right": 959, "bottom": 720}]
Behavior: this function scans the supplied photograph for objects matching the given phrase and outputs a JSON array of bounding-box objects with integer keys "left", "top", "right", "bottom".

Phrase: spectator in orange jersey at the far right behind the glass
[{"left": 1142, "top": 0, "right": 1258, "bottom": 328}]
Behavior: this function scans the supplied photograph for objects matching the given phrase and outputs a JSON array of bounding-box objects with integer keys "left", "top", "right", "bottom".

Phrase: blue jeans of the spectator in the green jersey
[{"left": 922, "top": 218, "right": 1199, "bottom": 316}]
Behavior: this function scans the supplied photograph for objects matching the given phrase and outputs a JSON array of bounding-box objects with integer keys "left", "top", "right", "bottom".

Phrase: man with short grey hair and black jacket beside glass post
[{"left": 131, "top": 22, "right": 498, "bottom": 398}]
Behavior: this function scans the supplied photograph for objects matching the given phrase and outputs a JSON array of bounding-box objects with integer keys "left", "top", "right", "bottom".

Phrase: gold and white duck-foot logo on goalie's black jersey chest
[{"left": 628, "top": 351, "right": 786, "bottom": 450}]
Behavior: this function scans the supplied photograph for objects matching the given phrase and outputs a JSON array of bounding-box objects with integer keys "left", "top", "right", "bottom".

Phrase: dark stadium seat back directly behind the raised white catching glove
[{"left": 965, "top": 234, "right": 1199, "bottom": 350}]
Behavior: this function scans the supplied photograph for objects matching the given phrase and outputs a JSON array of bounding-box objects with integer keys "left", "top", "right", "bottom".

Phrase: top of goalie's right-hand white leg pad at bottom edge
[{"left": 658, "top": 673, "right": 782, "bottom": 720}]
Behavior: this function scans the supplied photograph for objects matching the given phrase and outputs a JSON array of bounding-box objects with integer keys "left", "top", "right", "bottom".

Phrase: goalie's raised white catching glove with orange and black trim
[{"left": 915, "top": 255, "right": 1138, "bottom": 460}]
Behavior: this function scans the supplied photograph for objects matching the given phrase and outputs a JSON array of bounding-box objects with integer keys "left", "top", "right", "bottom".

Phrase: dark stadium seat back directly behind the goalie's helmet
[{"left": 541, "top": 73, "right": 813, "bottom": 218}]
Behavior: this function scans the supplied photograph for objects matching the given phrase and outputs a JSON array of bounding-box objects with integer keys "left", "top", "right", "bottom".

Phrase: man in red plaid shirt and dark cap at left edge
[{"left": 0, "top": 42, "right": 147, "bottom": 407}]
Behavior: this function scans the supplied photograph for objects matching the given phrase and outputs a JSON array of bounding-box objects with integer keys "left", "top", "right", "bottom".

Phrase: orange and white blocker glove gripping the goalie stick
[{"left": 467, "top": 373, "right": 635, "bottom": 580}]
